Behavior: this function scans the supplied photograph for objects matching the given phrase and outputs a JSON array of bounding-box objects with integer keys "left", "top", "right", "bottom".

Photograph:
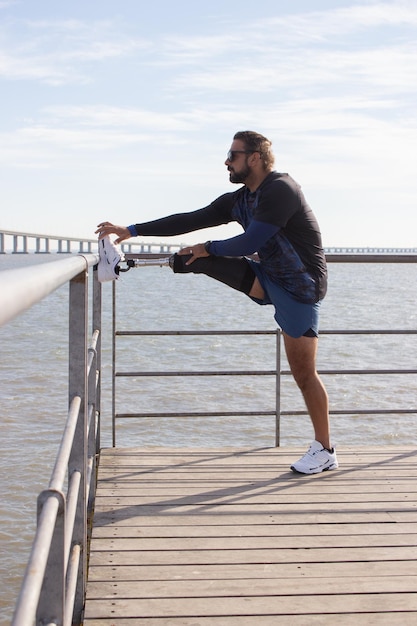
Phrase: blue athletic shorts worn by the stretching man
[{"left": 247, "top": 259, "right": 321, "bottom": 338}]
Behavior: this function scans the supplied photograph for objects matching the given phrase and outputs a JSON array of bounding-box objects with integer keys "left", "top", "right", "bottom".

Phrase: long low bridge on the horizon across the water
[{"left": 0, "top": 230, "right": 417, "bottom": 255}]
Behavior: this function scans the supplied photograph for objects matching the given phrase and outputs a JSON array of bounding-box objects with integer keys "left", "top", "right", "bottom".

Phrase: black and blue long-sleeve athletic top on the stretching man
[{"left": 134, "top": 172, "right": 327, "bottom": 302}]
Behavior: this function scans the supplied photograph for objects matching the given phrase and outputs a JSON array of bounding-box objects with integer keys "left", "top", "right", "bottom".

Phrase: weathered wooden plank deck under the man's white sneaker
[{"left": 84, "top": 446, "right": 417, "bottom": 626}]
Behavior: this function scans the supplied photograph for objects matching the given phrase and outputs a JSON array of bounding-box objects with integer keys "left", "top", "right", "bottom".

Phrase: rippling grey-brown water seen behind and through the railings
[{"left": 0, "top": 255, "right": 417, "bottom": 626}]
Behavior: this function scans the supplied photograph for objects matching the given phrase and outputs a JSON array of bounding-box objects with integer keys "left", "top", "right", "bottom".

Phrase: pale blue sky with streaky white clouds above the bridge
[{"left": 0, "top": 0, "right": 417, "bottom": 247}]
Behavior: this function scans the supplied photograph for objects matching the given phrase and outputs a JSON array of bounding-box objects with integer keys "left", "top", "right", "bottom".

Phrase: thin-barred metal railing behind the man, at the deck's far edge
[{"left": 112, "top": 252, "right": 417, "bottom": 446}]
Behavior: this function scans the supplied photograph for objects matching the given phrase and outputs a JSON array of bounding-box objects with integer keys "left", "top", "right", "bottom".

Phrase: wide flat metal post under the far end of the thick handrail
[{"left": 68, "top": 262, "right": 88, "bottom": 624}]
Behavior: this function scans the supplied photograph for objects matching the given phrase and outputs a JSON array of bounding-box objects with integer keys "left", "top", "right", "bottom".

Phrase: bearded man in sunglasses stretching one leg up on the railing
[{"left": 96, "top": 131, "right": 338, "bottom": 474}]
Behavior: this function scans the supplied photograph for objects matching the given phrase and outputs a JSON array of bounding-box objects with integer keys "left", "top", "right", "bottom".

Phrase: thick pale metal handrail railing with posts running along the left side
[{"left": 0, "top": 255, "right": 101, "bottom": 626}]
